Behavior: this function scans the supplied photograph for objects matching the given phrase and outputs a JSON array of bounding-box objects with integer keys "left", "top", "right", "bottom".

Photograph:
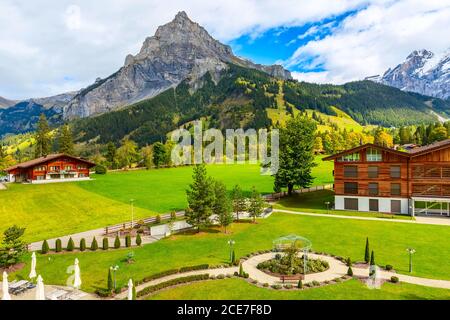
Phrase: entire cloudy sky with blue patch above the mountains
[{"left": 0, "top": 0, "right": 450, "bottom": 99}]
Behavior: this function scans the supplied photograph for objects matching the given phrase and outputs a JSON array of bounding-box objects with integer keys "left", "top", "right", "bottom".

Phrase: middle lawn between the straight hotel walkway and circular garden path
[{"left": 13, "top": 213, "right": 450, "bottom": 291}]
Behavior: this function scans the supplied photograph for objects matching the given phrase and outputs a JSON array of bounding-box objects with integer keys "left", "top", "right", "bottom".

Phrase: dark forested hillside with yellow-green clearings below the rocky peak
[{"left": 74, "top": 64, "right": 450, "bottom": 146}]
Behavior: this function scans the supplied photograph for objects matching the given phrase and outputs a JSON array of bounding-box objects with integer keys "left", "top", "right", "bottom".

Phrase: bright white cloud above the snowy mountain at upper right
[{"left": 285, "top": 0, "right": 450, "bottom": 83}]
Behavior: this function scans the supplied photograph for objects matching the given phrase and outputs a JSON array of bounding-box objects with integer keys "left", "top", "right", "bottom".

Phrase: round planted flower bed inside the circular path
[{"left": 257, "top": 254, "right": 330, "bottom": 276}]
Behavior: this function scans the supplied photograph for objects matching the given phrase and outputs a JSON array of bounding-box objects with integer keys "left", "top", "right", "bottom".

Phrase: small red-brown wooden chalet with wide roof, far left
[{"left": 6, "top": 154, "right": 95, "bottom": 183}]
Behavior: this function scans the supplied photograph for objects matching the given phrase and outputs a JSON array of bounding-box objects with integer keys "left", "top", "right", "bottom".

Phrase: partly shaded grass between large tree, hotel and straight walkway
[{"left": 274, "top": 190, "right": 413, "bottom": 220}]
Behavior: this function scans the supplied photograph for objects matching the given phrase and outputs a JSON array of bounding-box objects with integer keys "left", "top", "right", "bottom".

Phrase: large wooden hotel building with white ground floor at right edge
[{"left": 323, "top": 139, "right": 450, "bottom": 217}]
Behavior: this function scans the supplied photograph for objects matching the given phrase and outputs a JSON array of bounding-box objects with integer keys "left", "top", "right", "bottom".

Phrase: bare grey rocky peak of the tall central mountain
[{"left": 64, "top": 12, "right": 291, "bottom": 119}]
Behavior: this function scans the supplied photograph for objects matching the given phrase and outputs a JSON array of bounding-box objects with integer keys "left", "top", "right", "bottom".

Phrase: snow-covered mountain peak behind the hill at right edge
[{"left": 368, "top": 49, "right": 450, "bottom": 99}]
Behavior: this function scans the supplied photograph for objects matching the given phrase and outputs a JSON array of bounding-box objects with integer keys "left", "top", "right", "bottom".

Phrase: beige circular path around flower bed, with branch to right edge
[{"left": 242, "top": 252, "right": 450, "bottom": 289}]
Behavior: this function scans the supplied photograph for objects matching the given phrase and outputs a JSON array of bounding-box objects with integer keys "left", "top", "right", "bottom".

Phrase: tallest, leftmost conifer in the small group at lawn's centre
[{"left": 186, "top": 164, "right": 214, "bottom": 232}]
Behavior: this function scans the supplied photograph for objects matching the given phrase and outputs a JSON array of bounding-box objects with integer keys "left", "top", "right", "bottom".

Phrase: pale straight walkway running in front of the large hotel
[{"left": 273, "top": 209, "right": 450, "bottom": 226}]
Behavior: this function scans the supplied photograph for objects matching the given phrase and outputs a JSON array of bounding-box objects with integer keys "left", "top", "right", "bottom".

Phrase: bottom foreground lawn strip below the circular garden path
[{"left": 147, "top": 278, "right": 450, "bottom": 300}]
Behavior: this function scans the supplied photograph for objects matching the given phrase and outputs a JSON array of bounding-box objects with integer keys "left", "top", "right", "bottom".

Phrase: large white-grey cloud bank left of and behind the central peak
[{"left": 0, "top": 0, "right": 366, "bottom": 99}]
